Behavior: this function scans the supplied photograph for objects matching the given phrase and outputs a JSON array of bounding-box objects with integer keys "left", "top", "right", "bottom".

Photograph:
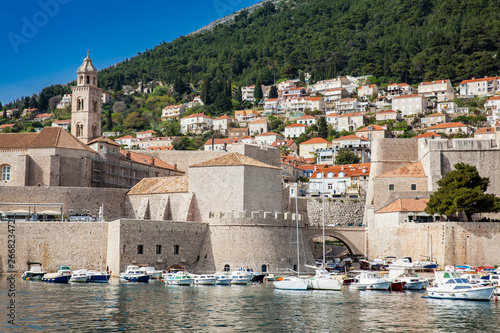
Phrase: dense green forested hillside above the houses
[{"left": 100, "top": 0, "right": 500, "bottom": 89}]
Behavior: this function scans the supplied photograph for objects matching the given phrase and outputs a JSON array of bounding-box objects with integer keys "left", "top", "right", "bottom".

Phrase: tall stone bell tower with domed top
[{"left": 71, "top": 51, "right": 102, "bottom": 143}]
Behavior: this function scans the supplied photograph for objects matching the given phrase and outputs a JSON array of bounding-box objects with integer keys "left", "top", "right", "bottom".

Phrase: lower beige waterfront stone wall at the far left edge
[{"left": 0, "top": 222, "right": 108, "bottom": 273}]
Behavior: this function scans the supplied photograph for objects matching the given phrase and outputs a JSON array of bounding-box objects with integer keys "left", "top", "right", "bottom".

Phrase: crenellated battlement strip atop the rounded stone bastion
[{"left": 206, "top": 210, "right": 304, "bottom": 227}]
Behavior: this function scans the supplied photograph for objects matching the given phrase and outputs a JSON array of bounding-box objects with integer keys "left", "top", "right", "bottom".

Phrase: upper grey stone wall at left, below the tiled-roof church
[{"left": 0, "top": 186, "right": 129, "bottom": 219}]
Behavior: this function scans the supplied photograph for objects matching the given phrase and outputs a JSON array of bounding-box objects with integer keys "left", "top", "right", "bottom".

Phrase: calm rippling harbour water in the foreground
[{"left": 0, "top": 276, "right": 500, "bottom": 332}]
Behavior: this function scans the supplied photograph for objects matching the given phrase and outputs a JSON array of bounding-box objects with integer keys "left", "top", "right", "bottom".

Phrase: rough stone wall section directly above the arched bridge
[{"left": 307, "top": 198, "right": 365, "bottom": 226}]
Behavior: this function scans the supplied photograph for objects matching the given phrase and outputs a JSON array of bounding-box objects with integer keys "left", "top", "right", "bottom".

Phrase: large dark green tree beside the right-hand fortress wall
[{"left": 425, "top": 163, "right": 500, "bottom": 221}]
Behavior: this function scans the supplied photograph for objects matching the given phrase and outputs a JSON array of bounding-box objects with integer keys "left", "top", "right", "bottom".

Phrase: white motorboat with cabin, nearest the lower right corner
[{"left": 427, "top": 271, "right": 495, "bottom": 301}]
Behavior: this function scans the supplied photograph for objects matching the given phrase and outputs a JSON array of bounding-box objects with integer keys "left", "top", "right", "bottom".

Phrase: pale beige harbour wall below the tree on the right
[{"left": 367, "top": 214, "right": 500, "bottom": 268}]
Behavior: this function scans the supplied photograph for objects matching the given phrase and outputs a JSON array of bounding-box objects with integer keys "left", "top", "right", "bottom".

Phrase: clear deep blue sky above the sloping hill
[{"left": 0, "top": 0, "right": 259, "bottom": 104}]
